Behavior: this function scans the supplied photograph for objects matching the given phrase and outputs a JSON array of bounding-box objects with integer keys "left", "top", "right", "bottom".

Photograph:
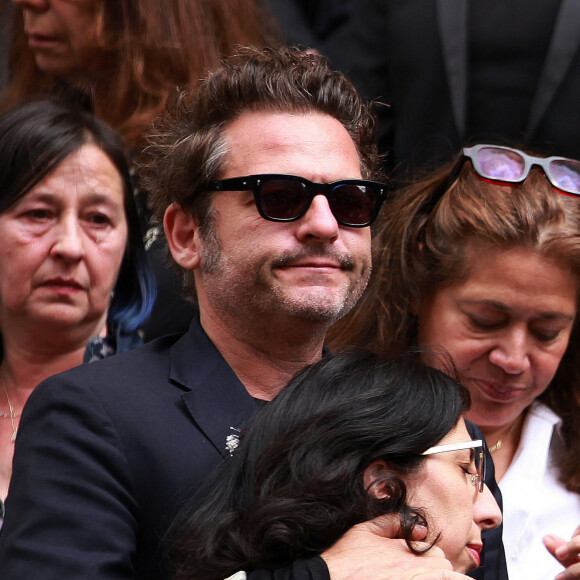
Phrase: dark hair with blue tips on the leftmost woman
[{"left": 0, "top": 99, "right": 155, "bottom": 332}]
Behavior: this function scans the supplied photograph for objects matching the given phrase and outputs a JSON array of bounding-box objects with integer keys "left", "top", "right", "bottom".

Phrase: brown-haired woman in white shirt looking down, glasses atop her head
[{"left": 331, "top": 145, "right": 580, "bottom": 580}]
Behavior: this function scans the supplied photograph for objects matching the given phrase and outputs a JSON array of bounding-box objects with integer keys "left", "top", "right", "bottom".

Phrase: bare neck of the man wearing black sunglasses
[{"left": 200, "top": 311, "right": 326, "bottom": 401}]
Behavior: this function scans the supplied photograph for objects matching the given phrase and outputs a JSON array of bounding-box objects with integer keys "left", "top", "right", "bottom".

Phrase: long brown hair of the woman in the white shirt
[{"left": 329, "top": 161, "right": 580, "bottom": 493}]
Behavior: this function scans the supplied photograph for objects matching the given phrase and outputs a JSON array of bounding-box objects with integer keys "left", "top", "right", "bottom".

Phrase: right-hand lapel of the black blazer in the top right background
[{"left": 526, "top": 0, "right": 580, "bottom": 140}]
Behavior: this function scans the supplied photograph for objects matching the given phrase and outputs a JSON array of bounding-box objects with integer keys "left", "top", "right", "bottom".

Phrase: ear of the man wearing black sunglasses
[{"left": 163, "top": 203, "right": 202, "bottom": 270}]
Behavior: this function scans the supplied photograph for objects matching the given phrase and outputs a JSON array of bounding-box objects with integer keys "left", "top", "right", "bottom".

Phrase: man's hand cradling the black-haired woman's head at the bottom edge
[{"left": 321, "top": 516, "right": 467, "bottom": 580}]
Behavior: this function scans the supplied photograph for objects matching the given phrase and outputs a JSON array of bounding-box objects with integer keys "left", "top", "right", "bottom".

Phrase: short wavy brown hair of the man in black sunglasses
[{"left": 140, "top": 47, "right": 383, "bottom": 296}]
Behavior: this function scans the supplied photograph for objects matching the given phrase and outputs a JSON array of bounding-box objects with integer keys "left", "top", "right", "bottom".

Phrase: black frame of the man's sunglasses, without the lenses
[{"left": 205, "top": 173, "right": 390, "bottom": 228}]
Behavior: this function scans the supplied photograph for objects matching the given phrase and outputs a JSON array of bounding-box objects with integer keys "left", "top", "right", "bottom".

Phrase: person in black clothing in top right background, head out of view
[{"left": 319, "top": 0, "right": 580, "bottom": 180}]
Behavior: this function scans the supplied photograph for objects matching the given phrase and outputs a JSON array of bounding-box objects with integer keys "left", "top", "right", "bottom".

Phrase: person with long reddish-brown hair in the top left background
[{"left": 0, "top": 0, "right": 277, "bottom": 340}]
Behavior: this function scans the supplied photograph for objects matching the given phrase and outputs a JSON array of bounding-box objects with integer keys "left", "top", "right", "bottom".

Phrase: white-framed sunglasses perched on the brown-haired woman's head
[{"left": 441, "top": 144, "right": 580, "bottom": 195}]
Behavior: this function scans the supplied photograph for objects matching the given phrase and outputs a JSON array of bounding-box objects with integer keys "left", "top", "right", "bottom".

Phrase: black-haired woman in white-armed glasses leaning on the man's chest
[{"left": 171, "top": 352, "right": 501, "bottom": 580}]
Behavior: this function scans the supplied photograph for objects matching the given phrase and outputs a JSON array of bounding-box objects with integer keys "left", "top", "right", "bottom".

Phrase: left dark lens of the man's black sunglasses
[{"left": 259, "top": 179, "right": 310, "bottom": 220}]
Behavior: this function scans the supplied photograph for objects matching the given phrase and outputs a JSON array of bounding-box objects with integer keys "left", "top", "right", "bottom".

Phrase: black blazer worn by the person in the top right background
[{"left": 322, "top": 0, "right": 580, "bottom": 173}]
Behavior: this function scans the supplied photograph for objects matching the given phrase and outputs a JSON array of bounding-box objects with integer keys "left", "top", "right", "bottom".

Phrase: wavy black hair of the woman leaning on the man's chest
[{"left": 172, "top": 352, "right": 466, "bottom": 579}]
